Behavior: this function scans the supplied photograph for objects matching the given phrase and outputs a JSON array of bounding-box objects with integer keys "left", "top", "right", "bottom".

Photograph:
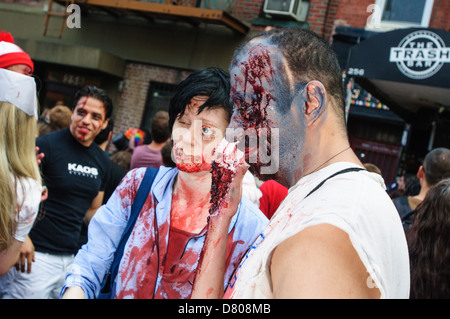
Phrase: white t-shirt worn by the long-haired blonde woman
[{"left": 12, "top": 177, "right": 42, "bottom": 242}]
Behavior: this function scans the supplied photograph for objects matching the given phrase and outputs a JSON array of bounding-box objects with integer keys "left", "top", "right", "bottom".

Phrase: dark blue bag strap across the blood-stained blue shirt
[{"left": 98, "top": 167, "right": 158, "bottom": 298}]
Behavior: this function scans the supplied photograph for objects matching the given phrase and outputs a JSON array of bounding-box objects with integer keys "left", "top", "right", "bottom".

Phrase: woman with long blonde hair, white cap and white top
[{"left": 0, "top": 69, "right": 43, "bottom": 275}]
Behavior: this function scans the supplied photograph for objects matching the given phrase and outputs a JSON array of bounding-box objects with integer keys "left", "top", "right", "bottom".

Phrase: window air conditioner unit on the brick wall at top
[{"left": 263, "top": 0, "right": 309, "bottom": 21}]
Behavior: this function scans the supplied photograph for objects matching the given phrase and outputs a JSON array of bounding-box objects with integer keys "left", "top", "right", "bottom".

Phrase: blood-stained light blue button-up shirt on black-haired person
[{"left": 61, "top": 166, "right": 268, "bottom": 298}]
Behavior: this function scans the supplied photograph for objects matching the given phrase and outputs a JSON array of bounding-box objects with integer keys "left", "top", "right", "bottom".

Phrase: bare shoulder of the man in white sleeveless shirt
[{"left": 270, "top": 224, "right": 380, "bottom": 298}]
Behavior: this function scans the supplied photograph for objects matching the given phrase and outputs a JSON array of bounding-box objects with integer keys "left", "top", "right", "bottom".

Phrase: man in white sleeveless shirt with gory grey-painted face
[{"left": 192, "top": 28, "right": 409, "bottom": 298}]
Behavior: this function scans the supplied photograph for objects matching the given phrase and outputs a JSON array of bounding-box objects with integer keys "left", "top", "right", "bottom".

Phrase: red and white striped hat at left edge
[{"left": 0, "top": 31, "right": 34, "bottom": 72}]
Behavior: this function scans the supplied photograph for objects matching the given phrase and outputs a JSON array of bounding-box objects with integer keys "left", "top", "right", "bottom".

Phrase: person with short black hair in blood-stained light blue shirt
[{"left": 61, "top": 68, "right": 268, "bottom": 299}]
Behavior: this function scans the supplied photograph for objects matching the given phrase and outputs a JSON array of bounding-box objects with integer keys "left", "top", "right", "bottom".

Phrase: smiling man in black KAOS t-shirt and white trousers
[{"left": 3, "top": 86, "right": 112, "bottom": 299}]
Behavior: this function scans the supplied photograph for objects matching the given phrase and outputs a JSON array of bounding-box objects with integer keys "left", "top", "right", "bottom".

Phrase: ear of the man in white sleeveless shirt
[{"left": 304, "top": 81, "right": 327, "bottom": 125}]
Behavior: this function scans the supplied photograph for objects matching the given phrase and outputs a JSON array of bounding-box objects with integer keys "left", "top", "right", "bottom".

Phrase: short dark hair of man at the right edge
[{"left": 422, "top": 147, "right": 450, "bottom": 186}]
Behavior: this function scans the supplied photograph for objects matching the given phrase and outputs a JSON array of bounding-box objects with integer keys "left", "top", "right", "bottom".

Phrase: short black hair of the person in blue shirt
[{"left": 169, "top": 67, "right": 233, "bottom": 132}]
